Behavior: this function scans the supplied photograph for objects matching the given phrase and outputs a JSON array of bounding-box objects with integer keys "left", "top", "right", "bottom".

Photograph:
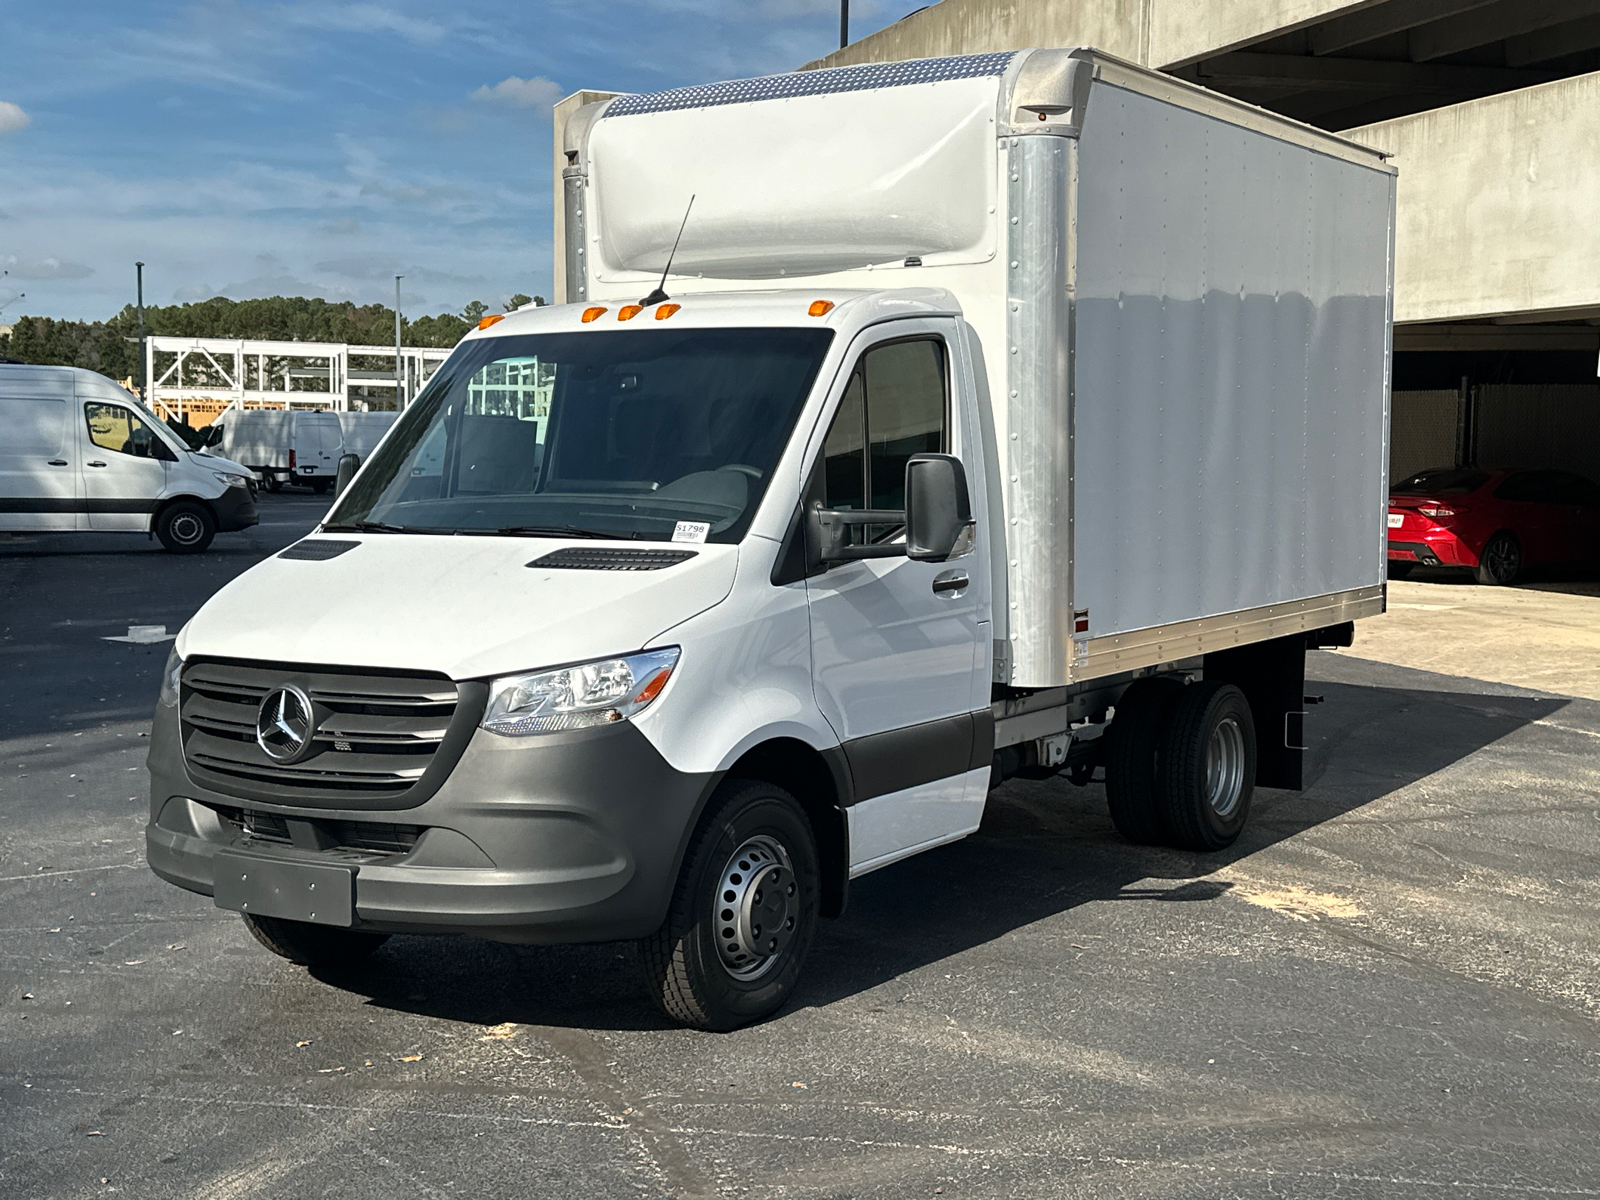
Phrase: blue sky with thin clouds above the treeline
[{"left": 0, "top": 0, "right": 922, "bottom": 323}]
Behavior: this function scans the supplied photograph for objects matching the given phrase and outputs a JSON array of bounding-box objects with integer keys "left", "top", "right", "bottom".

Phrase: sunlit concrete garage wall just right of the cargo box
[{"left": 1344, "top": 72, "right": 1600, "bottom": 329}]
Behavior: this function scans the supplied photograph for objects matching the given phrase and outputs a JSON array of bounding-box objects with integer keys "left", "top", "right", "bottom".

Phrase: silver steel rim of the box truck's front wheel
[{"left": 712, "top": 834, "right": 800, "bottom": 981}]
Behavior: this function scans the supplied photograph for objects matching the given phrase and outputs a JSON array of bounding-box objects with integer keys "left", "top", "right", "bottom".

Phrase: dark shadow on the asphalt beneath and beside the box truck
[{"left": 317, "top": 672, "right": 1570, "bottom": 1029}]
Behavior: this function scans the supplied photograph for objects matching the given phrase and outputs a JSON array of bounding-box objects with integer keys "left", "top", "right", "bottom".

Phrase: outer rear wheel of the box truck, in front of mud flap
[{"left": 1158, "top": 680, "right": 1256, "bottom": 853}]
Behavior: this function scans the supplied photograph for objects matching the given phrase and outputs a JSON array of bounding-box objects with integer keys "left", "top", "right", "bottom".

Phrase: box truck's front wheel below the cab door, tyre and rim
[{"left": 640, "top": 779, "right": 821, "bottom": 1030}]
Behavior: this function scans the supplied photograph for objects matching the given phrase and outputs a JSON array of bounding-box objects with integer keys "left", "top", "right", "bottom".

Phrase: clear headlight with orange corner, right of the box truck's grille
[{"left": 483, "top": 646, "right": 678, "bottom": 738}]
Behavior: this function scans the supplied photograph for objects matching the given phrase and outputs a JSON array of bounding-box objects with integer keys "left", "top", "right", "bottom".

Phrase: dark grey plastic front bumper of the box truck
[{"left": 146, "top": 709, "right": 717, "bottom": 942}]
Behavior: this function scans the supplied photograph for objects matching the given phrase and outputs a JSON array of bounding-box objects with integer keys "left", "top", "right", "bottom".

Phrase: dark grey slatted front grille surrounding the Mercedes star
[{"left": 181, "top": 659, "right": 482, "bottom": 808}]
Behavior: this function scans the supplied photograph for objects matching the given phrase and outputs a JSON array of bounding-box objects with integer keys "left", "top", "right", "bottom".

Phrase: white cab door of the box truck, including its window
[{"left": 806, "top": 320, "right": 992, "bottom": 875}]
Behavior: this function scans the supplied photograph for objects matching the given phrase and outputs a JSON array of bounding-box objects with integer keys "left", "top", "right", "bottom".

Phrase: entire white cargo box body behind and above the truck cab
[{"left": 565, "top": 50, "right": 1394, "bottom": 688}]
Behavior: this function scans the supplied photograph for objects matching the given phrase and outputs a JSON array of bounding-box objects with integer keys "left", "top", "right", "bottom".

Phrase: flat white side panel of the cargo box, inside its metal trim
[{"left": 1072, "top": 83, "right": 1394, "bottom": 637}]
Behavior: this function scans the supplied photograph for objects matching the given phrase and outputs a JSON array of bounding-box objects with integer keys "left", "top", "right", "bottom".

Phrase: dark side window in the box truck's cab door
[{"left": 822, "top": 338, "right": 950, "bottom": 509}]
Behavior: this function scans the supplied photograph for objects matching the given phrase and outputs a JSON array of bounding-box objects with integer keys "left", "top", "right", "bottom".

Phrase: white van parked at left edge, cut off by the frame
[{"left": 0, "top": 363, "right": 258, "bottom": 554}]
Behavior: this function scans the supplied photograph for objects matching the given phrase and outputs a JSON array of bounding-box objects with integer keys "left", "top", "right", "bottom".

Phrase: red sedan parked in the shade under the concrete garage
[{"left": 1389, "top": 467, "right": 1600, "bottom": 584}]
